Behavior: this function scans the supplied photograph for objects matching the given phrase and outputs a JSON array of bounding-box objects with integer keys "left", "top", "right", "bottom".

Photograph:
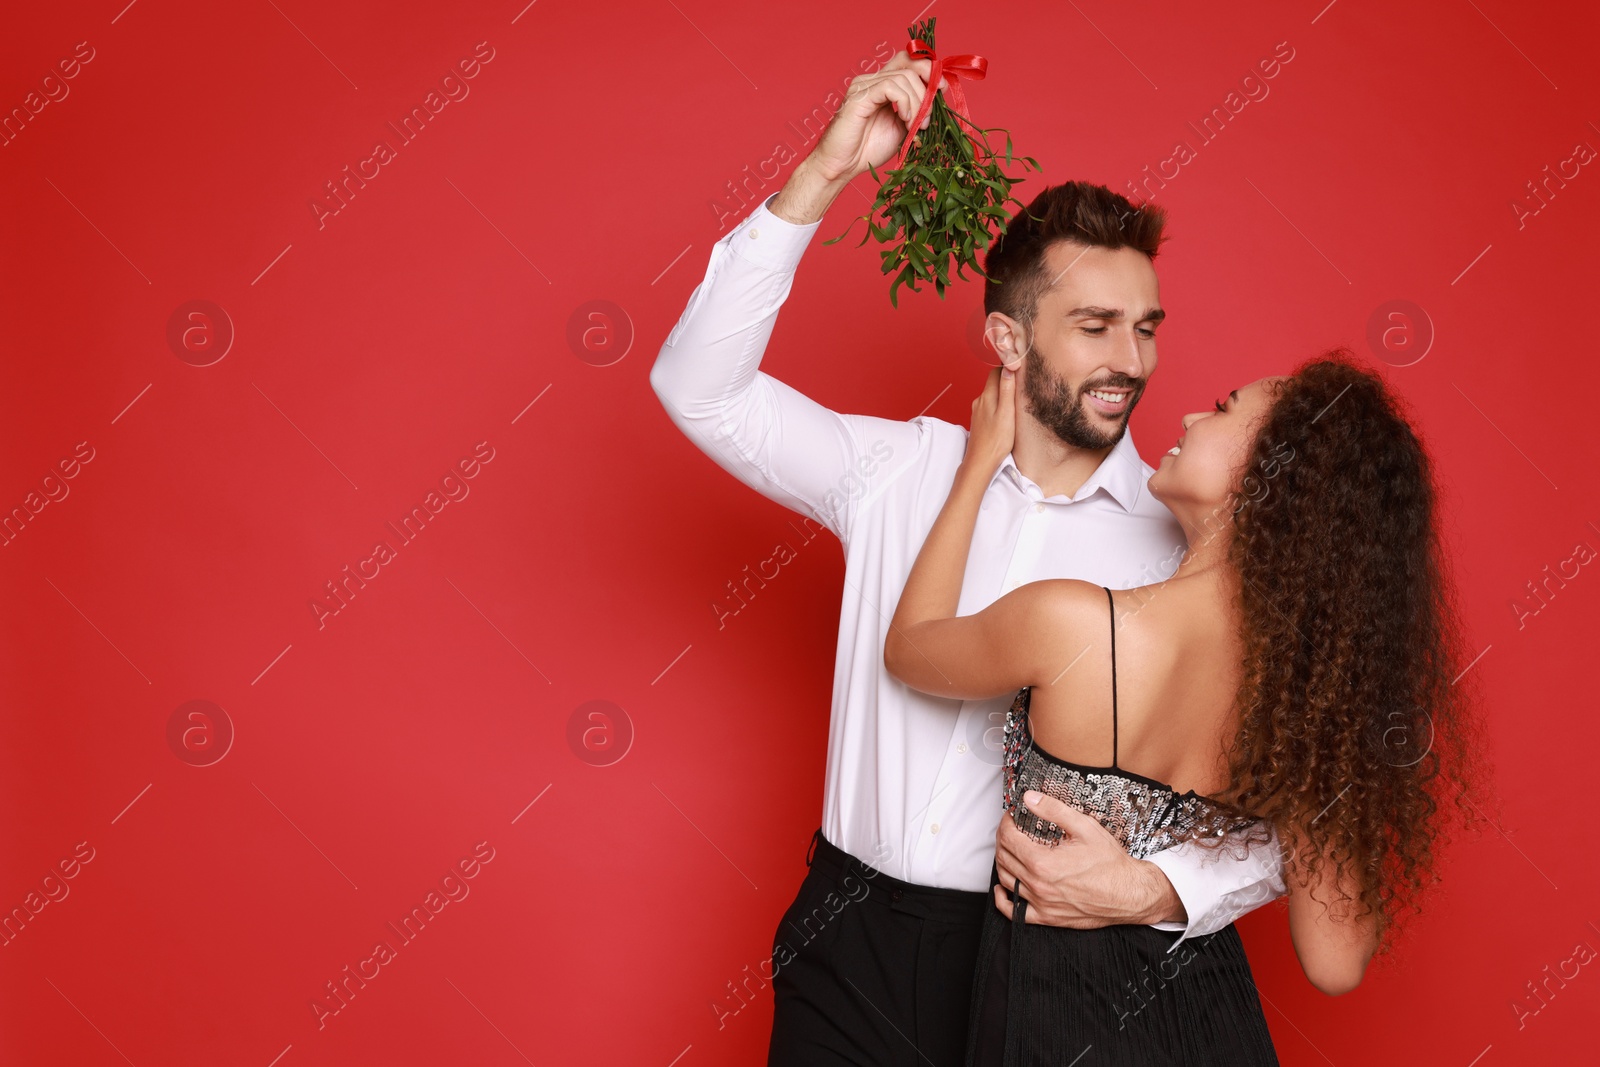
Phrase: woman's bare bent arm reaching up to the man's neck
[{"left": 883, "top": 368, "right": 1106, "bottom": 699}]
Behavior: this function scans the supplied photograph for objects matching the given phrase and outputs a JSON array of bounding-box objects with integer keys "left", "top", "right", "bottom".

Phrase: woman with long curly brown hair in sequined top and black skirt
[{"left": 883, "top": 352, "right": 1469, "bottom": 1067}]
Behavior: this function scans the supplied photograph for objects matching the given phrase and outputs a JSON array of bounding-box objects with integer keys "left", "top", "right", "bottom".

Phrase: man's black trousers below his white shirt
[{"left": 766, "top": 830, "right": 994, "bottom": 1067}]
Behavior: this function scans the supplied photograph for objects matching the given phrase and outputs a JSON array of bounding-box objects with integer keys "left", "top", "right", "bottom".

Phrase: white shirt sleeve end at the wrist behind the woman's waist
[{"left": 1147, "top": 830, "right": 1288, "bottom": 952}]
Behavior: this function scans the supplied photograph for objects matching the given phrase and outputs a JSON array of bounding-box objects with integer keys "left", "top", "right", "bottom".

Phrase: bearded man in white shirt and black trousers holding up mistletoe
[{"left": 650, "top": 51, "right": 1283, "bottom": 1067}]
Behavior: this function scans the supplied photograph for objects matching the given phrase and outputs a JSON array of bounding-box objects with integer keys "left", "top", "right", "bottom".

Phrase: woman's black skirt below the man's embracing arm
[{"left": 966, "top": 872, "right": 1278, "bottom": 1067}]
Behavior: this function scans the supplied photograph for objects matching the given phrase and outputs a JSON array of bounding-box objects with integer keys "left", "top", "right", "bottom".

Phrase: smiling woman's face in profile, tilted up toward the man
[{"left": 1149, "top": 378, "right": 1283, "bottom": 510}]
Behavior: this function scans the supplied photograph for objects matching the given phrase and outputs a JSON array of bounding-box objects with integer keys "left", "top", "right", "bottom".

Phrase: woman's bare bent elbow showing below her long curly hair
[{"left": 1280, "top": 832, "right": 1382, "bottom": 997}]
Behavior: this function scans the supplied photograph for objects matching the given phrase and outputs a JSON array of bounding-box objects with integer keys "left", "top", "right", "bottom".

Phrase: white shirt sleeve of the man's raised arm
[{"left": 650, "top": 194, "right": 925, "bottom": 542}]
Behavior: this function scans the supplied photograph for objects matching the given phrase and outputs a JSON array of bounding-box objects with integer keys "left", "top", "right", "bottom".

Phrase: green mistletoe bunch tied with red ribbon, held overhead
[{"left": 824, "top": 18, "right": 1040, "bottom": 309}]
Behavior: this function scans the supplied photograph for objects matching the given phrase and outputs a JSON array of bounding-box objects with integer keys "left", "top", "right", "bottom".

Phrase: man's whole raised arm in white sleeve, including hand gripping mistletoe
[{"left": 650, "top": 53, "right": 930, "bottom": 541}]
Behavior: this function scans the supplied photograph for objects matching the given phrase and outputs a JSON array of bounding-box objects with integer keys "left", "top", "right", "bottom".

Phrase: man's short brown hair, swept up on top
[{"left": 984, "top": 181, "right": 1166, "bottom": 330}]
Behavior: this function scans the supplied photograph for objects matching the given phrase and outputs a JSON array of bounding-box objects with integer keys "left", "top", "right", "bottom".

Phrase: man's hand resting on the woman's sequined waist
[{"left": 995, "top": 789, "right": 1187, "bottom": 929}]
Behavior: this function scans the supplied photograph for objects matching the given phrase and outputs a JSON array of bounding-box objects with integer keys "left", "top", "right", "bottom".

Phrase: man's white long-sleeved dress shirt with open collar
[{"left": 650, "top": 194, "right": 1285, "bottom": 936}]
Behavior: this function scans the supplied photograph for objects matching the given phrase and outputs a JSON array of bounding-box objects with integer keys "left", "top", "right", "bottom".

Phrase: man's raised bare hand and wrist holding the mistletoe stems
[{"left": 771, "top": 50, "right": 944, "bottom": 226}]
